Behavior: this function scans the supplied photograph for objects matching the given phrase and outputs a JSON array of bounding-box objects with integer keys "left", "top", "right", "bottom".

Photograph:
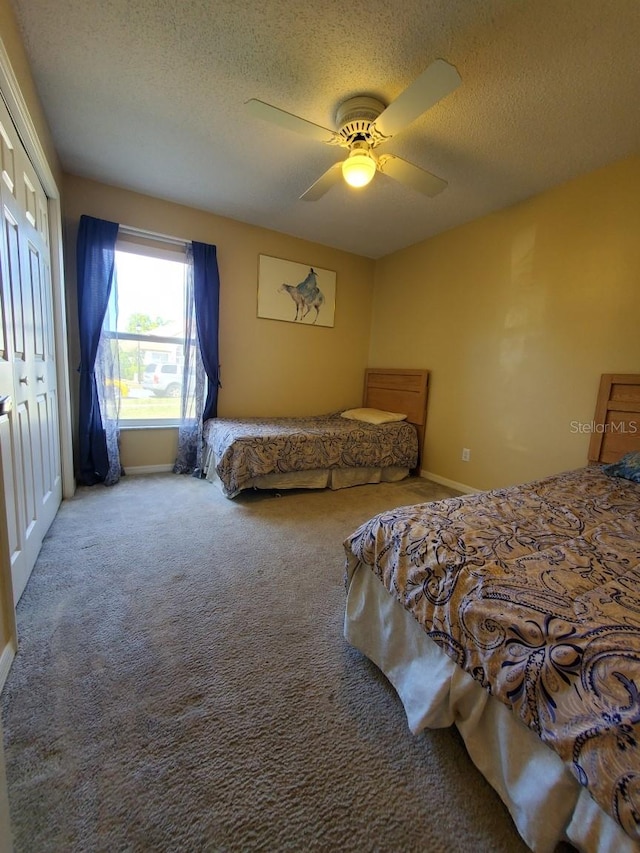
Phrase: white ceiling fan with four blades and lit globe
[{"left": 245, "top": 59, "right": 461, "bottom": 201}]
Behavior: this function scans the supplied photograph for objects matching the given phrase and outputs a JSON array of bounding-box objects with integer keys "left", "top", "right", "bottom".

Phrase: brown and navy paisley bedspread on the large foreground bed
[{"left": 345, "top": 466, "right": 640, "bottom": 840}]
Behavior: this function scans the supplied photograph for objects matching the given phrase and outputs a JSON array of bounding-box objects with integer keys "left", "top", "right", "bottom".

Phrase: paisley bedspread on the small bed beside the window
[{"left": 205, "top": 412, "right": 418, "bottom": 498}]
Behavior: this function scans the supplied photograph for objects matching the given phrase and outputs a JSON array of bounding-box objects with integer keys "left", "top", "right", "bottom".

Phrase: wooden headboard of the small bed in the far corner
[{"left": 362, "top": 367, "right": 429, "bottom": 471}]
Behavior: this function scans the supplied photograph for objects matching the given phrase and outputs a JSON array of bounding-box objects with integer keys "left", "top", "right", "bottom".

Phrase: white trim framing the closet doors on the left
[{"left": 0, "top": 38, "right": 76, "bottom": 498}]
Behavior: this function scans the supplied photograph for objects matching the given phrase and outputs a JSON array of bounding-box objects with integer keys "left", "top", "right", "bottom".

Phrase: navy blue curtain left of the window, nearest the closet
[{"left": 76, "top": 216, "right": 118, "bottom": 486}]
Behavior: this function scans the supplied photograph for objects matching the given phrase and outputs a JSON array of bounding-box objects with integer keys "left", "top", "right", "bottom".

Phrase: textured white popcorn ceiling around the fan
[{"left": 8, "top": 0, "right": 640, "bottom": 258}]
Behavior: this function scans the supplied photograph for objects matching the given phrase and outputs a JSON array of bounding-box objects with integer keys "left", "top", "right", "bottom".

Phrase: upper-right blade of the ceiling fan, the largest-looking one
[{"left": 375, "top": 59, "right": 461, "bottom": 136}]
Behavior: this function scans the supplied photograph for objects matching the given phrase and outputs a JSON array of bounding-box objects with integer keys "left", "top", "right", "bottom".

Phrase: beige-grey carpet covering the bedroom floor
[{"left": 2, "top": 474, "right": 548, "bottom": 853}]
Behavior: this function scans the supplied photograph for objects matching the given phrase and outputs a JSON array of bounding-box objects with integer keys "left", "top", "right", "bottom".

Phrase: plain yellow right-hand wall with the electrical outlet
[{"left": 369, "top": 151, "right": 640, "bottom": 489}]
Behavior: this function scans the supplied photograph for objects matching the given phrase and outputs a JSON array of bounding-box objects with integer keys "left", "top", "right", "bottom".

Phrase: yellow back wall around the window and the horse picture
[{"left": 63, "top": 175, "right": 374, "bottom": 468}]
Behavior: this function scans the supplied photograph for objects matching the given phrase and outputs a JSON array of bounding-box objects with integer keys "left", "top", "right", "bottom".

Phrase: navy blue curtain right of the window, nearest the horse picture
[{"left": 192, "top": 242, "right": 220, "bottom": 422}]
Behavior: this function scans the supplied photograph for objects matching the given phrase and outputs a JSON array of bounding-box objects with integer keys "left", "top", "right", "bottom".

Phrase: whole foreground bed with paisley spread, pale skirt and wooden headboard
[{"left": 345, "top": 374, "right": 640, "bottom": 853}]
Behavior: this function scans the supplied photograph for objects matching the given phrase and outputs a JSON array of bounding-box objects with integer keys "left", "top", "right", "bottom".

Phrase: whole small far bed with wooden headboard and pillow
[{"left": 204, "top": 368, "right": 429, "bottom": 498}]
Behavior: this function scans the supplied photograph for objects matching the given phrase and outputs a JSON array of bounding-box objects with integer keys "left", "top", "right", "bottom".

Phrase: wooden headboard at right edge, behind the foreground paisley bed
[{"left": 589, "top": 373, "right": 640, "bottom": 462}]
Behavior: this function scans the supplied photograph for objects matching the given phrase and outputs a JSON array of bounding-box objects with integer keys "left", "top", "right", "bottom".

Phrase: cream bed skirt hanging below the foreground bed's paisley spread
[{"left": 344, "top": 565, "right": 640, "bottom": 853}]
